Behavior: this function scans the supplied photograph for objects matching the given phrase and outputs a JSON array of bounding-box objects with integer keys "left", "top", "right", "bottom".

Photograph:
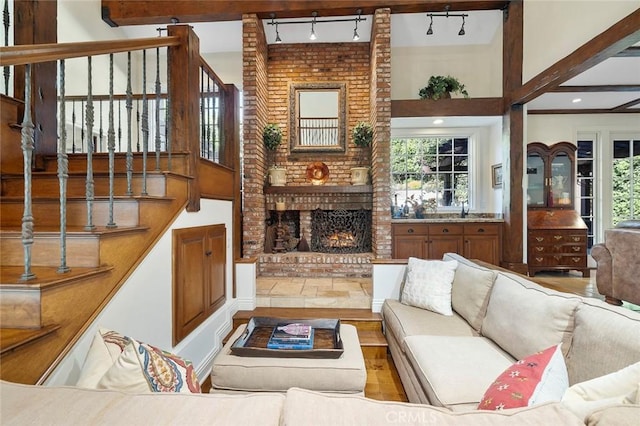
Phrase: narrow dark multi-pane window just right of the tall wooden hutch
[{"left": 578, "top": 135, "right": 597, "bottom": 250}]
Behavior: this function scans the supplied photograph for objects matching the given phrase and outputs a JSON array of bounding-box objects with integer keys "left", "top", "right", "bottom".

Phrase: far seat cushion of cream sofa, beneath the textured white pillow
[{"left": 382, "top": 299, "right": 477, "bottom": 350}]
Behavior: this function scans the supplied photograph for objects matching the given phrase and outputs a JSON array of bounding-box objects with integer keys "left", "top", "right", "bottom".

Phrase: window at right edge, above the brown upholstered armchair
[{"left": 611, "top": 139, "right": 640, "bottom": 226}]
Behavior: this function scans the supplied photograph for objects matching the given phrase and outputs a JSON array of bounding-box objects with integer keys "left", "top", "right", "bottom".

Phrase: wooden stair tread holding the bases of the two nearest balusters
[{"left": 0, "top": 265, "right": 113, "bottom": 289}]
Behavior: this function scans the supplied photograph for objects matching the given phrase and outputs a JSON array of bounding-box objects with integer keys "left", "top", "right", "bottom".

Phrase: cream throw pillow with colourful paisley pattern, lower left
[{"left": 96, "top": 339, "right": 200, "bottom": 393}]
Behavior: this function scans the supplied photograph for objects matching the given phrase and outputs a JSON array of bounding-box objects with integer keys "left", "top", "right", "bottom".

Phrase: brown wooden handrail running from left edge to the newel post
[{"left": 0, "top": 36, "right": 180, "bottom": 67}]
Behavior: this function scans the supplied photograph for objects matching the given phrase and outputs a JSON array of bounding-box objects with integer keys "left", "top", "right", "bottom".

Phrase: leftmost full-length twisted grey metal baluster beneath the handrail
[{"left": 20, "top": 64, "right": 36, "bottom": 281}]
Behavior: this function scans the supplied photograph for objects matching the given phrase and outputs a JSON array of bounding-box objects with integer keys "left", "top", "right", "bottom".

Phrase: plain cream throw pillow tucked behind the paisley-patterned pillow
[{"left": 76, "top": 328, "right": 131, "bottom": 389}]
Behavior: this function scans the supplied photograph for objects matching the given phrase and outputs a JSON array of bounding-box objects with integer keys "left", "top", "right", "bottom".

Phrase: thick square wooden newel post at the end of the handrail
[{"left": 167, "top": 25, "right": 200, "bottom": 212}]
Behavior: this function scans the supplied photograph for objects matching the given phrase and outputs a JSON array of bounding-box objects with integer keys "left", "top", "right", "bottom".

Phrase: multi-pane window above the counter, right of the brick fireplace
[{"left": 391, "top": 137, "right": 471, "bottom": 217}]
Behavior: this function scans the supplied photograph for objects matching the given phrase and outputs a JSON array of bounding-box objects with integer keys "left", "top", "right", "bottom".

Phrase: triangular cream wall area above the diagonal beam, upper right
[{"left": 522, "top": 0, "right": 640, "bottom": 82}]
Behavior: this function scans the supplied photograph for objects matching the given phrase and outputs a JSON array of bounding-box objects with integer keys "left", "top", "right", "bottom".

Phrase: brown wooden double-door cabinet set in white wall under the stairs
[{"left": 173, "top": 225, "right": 227, "bottom": 345}]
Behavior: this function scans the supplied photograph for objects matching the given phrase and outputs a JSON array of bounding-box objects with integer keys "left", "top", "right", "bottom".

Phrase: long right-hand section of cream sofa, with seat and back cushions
[{"left": 382, "top": 253, "right": 640, "bottom": 418}]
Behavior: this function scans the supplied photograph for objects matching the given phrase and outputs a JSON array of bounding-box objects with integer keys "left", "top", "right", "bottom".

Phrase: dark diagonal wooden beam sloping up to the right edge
[{"left": 511, "top": 9, "right": 640, "bottom": 104}]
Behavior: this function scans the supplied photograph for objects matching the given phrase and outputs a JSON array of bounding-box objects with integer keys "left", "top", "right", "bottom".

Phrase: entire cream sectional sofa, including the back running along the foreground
[{"left": 0, "top": 254, "right": 640, "bottom": 426}]
